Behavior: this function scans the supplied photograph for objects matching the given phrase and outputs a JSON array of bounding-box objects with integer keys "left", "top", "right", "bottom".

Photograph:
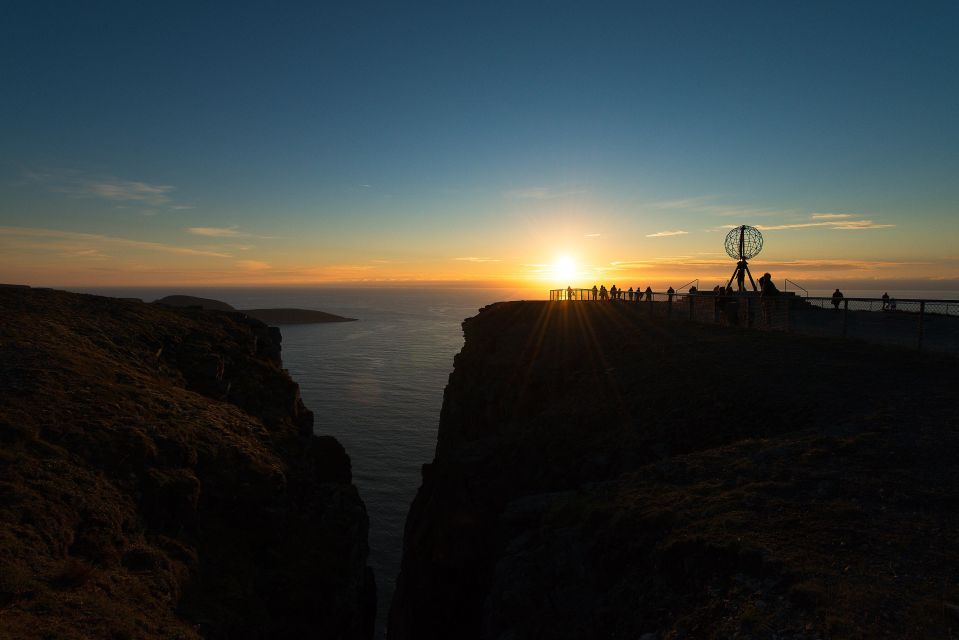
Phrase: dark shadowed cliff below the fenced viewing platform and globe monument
[{"left": 389, "top": 303, "right": 959, "bottom": 640}]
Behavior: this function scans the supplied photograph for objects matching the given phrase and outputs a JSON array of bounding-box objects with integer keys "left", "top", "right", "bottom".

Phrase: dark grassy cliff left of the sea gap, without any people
[{"left": 0, "top": 288, "right": 375, "bottom": 639}]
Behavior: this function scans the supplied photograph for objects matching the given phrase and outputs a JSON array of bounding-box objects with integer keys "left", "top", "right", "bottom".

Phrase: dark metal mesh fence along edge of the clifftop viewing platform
[{"left": 550, "top": 289, "right": 959, "bottom": 354}]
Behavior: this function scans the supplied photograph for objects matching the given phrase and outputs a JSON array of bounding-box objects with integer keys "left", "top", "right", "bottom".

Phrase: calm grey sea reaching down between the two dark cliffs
[{"left": 75, "top": 288, "right": 545, "bottom": 634}]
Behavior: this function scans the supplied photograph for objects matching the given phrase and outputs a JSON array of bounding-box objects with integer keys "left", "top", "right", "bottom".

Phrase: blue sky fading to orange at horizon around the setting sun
[{"left": 0, "top": 0, "right": 959, "bottom": 288}]
